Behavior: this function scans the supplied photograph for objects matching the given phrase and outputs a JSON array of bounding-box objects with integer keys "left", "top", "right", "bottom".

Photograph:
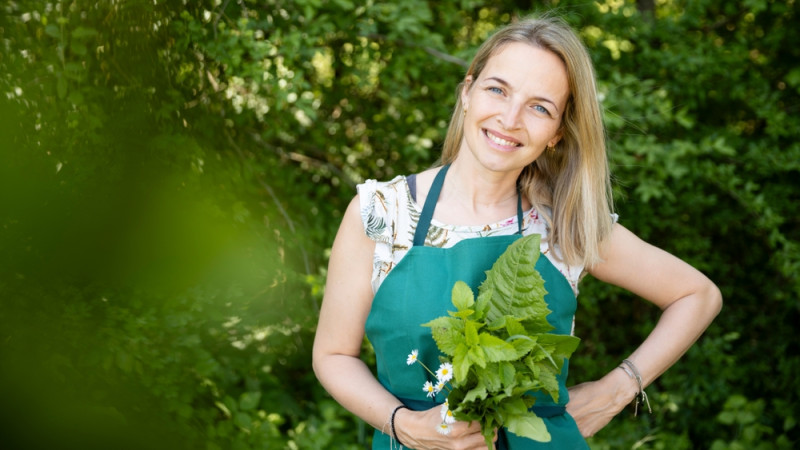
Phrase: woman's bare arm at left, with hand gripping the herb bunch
[{"left": 313, "top": 197, "right": 486, "bottom": 449}]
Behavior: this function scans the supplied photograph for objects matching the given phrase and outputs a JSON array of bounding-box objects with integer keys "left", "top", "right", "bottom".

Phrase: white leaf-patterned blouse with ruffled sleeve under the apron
[{"left": 358, "top": 175, "right": 583, "bottom": 295}]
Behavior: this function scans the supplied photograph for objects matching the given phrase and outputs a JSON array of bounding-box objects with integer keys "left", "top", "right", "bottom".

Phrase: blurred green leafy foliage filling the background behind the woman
[{"left": 0, "top": 0, "right": 800, "bottom": 449}]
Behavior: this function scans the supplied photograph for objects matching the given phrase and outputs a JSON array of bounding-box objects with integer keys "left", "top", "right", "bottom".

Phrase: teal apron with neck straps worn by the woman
[{"left": 366, "top": 166, "right": 589, "bottom": 450}]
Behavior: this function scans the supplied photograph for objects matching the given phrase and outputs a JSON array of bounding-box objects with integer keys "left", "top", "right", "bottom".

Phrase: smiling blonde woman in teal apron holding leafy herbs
[{"left": 314, "top": 15, "right": 722, "bottom": 449}]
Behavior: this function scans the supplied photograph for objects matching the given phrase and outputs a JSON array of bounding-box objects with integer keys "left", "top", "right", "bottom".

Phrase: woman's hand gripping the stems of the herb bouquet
[{"left": 394, "top": 406, "right": 497, "bottom": 450}]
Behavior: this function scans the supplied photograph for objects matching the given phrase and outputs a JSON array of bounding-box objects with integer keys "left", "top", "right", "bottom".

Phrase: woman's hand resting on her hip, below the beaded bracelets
[{"left": 567, "top": 369, "right": 638, "bottom": 437}]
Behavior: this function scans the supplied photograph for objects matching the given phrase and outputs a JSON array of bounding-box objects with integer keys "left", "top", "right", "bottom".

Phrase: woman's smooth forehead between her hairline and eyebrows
[{"left": 478, "top": 42, "right": 569, "bottom": 104}]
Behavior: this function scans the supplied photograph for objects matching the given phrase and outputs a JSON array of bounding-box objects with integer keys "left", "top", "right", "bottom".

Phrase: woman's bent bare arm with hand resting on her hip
[{"left": 567, "top": 224, "right": 722, "bottom": 436}]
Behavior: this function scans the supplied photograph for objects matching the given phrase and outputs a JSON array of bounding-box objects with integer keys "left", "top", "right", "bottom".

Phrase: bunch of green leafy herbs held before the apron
[{"left": 423, "top": 235, "right": 579, "bottom": 447}]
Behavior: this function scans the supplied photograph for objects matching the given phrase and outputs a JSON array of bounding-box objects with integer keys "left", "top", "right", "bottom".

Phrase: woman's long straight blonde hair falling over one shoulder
[{"left": 442, "top": 17, "right": 613, "bottom": 267}]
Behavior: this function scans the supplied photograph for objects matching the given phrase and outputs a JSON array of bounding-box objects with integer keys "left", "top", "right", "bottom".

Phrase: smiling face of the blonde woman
[{"left": 458, "top": 42, "right": 569, "bottom": 174}]
